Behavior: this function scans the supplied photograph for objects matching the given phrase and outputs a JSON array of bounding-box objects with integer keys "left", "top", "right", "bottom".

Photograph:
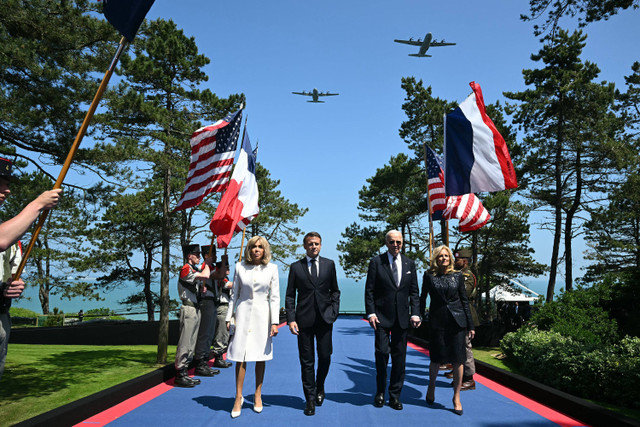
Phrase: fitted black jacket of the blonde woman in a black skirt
[{"left": 420, "top": 272, "right": 474, "bottom": 330}]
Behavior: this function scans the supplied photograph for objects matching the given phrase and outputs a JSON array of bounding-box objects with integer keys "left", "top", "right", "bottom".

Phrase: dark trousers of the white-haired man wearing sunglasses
[{"left": 375, "top": 322, "right": 408, "bottom": 399}]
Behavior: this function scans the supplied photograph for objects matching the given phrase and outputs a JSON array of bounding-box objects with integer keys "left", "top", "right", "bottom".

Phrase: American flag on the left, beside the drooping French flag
[{"left": 174, "top": 109, "right": 242, "bottom": 211}]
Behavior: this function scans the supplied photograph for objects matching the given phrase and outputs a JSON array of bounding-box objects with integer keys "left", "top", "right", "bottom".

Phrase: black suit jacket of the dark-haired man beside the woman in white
[{"left": 285, "top": 257, "right": 340, "bottom": 328}]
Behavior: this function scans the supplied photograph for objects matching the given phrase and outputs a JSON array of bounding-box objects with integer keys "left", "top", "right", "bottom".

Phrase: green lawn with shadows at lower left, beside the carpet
[{"left": 0, "top": 344, "right": 176, "bottom": 426}]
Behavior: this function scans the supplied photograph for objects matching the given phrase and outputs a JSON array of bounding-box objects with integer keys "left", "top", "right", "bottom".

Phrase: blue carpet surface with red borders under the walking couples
[{"left": 99, "top": 317, "right": 582, "bottom": 427}]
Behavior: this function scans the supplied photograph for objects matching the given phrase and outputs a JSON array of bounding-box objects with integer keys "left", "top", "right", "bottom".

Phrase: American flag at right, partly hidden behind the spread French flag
[{"left": 426, "top": 147, "right": 491, "bottom": 232}]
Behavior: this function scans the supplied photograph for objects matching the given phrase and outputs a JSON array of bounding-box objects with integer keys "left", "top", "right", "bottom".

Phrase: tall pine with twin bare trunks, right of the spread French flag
[{"left": 505, "top": 30, "right": 619, "bottom": 301}]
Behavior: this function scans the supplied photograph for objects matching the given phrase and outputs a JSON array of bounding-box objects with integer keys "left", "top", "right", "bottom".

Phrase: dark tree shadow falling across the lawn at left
[{"left": 0, "top": 349, "right": 155, "bottom": 403}]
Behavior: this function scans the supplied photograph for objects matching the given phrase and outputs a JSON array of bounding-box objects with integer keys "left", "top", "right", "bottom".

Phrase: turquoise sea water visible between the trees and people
[{"left": 13, "top": 271, "right": 564, "bottom": 320}]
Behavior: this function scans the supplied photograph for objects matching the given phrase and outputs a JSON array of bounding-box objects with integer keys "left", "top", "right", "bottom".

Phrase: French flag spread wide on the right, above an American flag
[{"left": 444, "top": 82, "right": 518, "bottom": 196}]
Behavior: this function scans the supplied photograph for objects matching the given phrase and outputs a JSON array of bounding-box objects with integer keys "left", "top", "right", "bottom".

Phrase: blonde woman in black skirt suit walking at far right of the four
[{"left": 420, "top": 246, "right": 475, "bottom": 415}]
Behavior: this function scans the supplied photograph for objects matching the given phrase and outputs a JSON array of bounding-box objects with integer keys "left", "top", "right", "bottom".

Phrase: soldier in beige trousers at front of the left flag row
[{"left": 174, "top": 244, "right": 210, "bottom": 387}]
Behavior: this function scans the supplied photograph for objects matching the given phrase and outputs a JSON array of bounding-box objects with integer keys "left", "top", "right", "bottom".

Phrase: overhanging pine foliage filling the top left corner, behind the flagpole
[{"left": 0, "top": 0, "right": 117, "bottom": 171}]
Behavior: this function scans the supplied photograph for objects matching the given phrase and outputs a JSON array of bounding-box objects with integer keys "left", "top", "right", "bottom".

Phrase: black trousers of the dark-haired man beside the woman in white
[{"left": 298, "top": 316, "right": 333, "bottom": 401}]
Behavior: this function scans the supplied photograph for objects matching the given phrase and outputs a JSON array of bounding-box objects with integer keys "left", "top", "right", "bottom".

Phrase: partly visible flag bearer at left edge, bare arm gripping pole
[{"left": 0, "top": 158, "right": 62, "bottom": 378}]
